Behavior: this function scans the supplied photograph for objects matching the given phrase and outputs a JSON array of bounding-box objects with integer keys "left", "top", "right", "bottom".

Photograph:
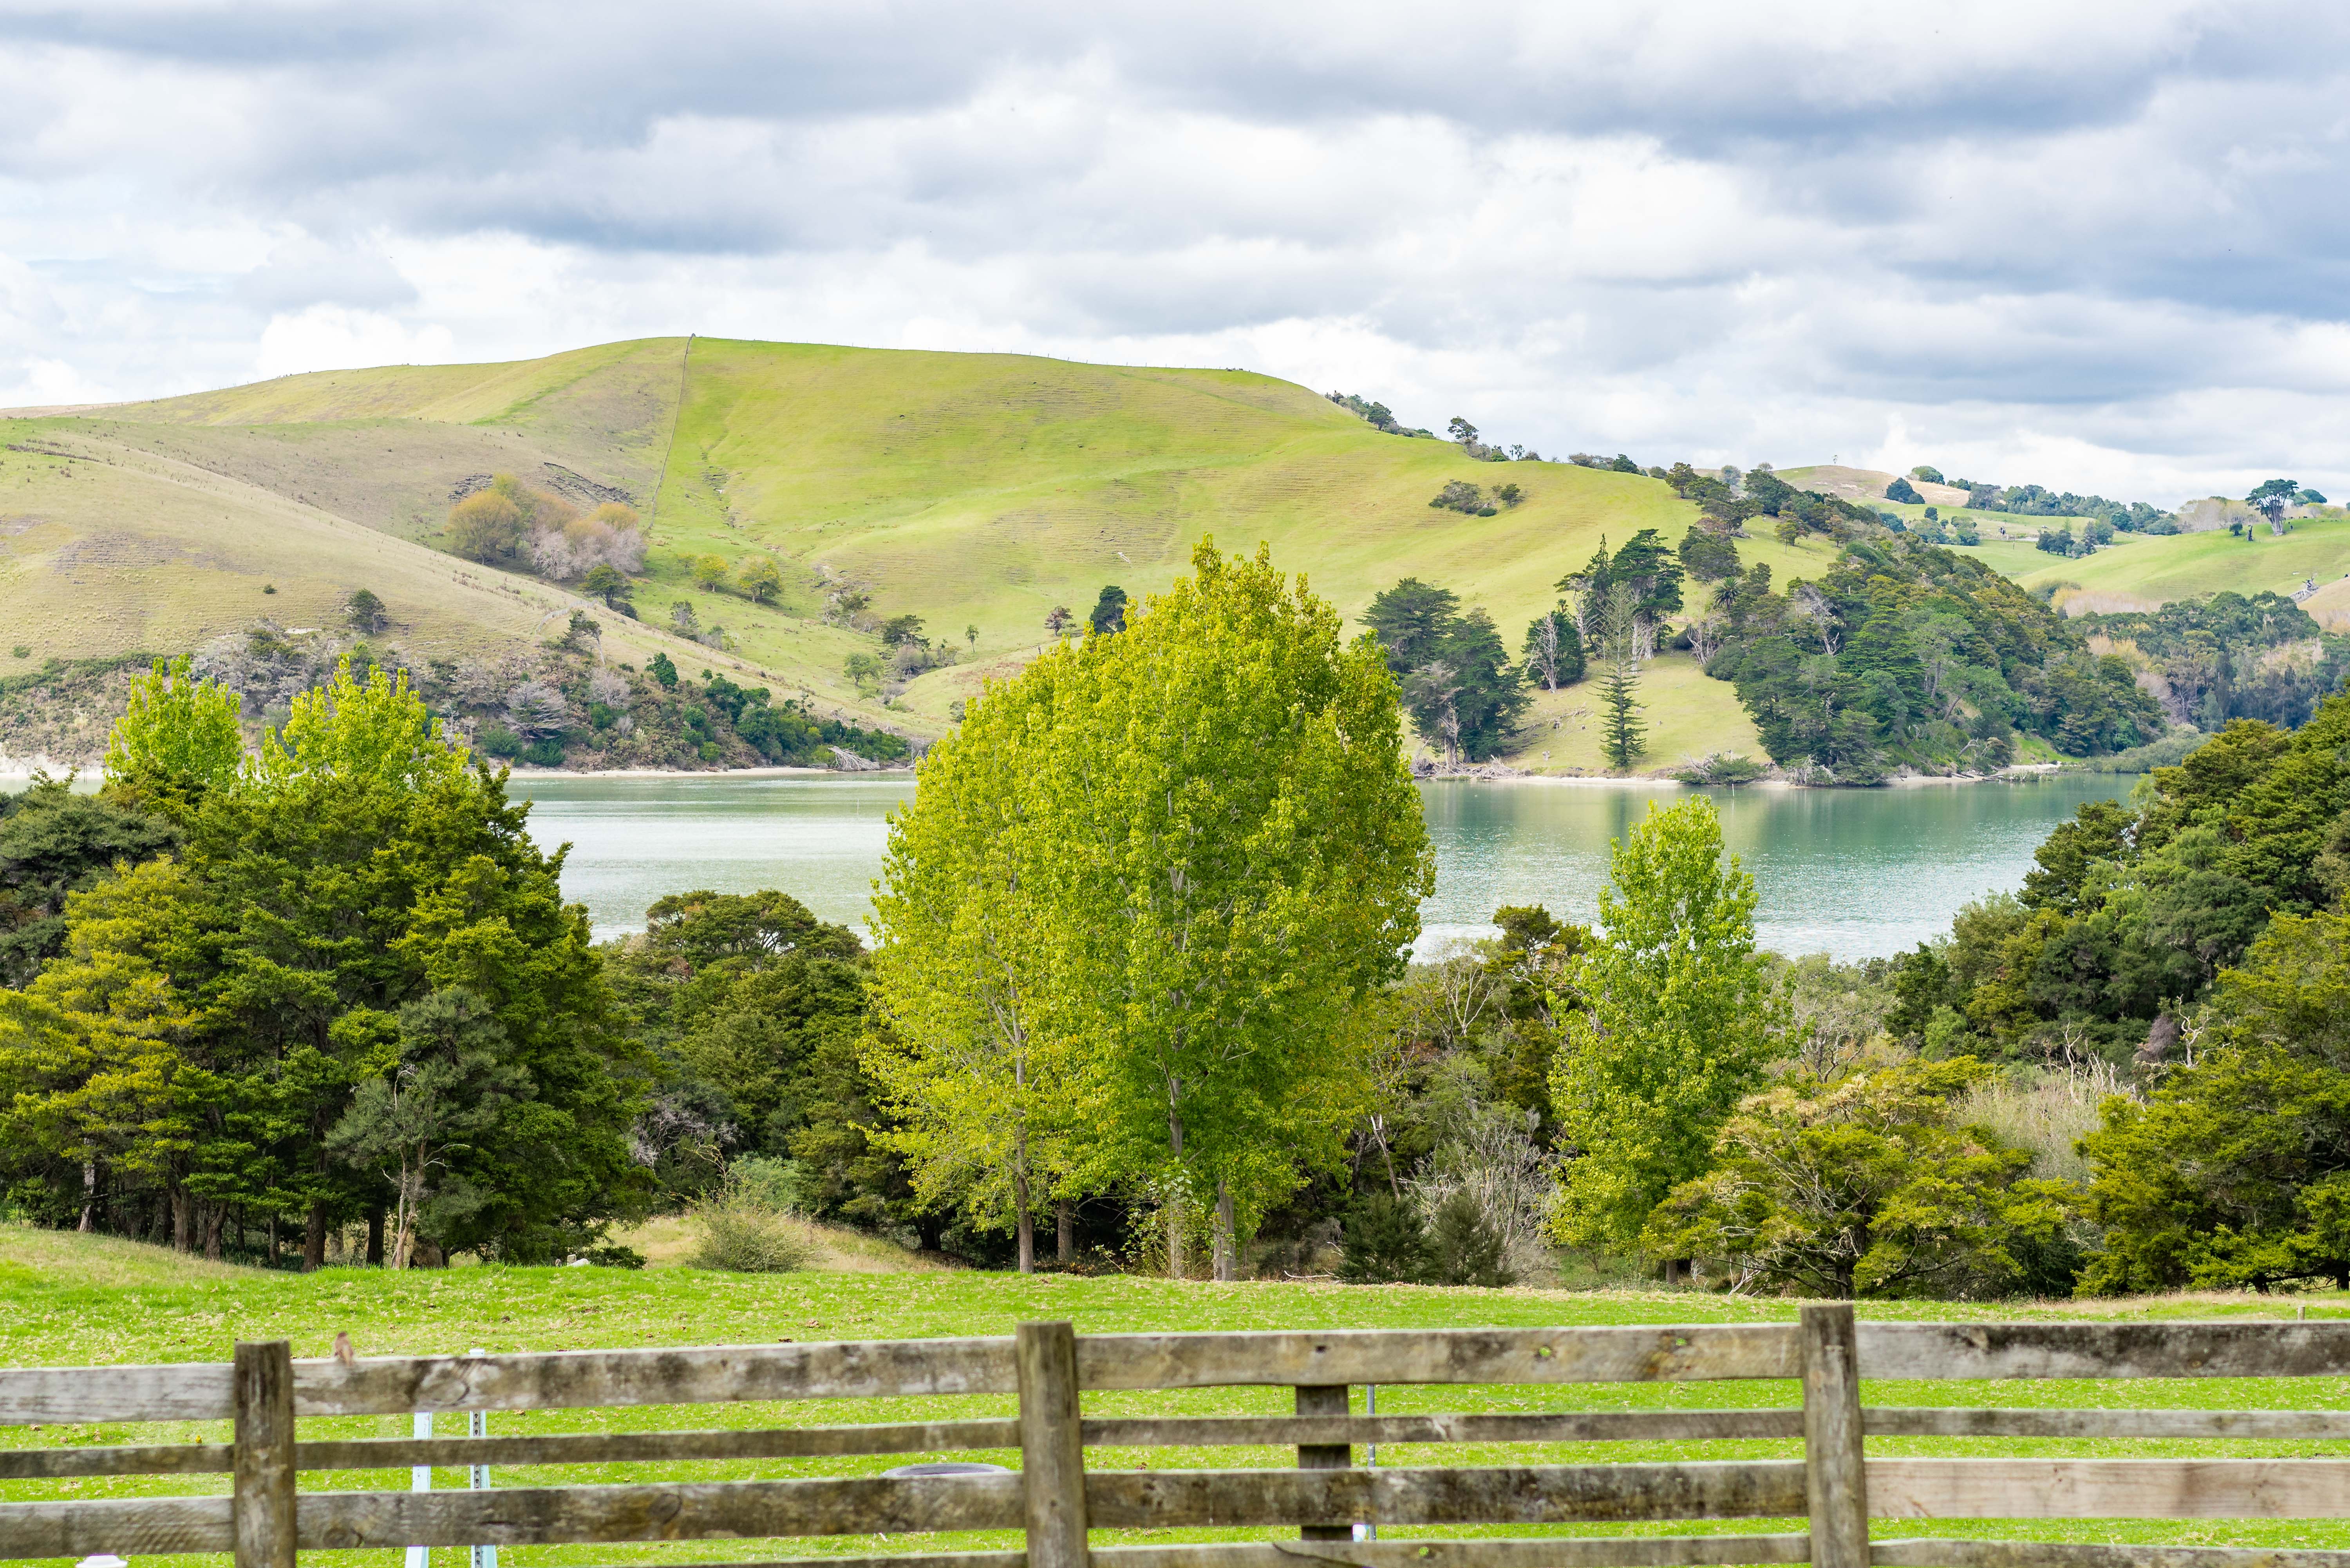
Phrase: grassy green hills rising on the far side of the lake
[{"left": 0, "top": 338, "right": 2350, "bottom": 771}]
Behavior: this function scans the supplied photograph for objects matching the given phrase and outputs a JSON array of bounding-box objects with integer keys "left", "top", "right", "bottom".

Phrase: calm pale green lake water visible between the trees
[{"left": 515, "top": 773, "right": 2136, "bottom": 959}]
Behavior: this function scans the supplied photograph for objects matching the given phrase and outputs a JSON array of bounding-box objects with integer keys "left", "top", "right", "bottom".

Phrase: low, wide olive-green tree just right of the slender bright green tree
[{"left": 1640, "top": 1058, "right": 2068, "bottom": 1300}]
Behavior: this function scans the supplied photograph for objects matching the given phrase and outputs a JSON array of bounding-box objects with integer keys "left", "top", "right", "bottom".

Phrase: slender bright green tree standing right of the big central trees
[{"left": 1551, "top": 799, "right": 1784, "bottom": 1248}]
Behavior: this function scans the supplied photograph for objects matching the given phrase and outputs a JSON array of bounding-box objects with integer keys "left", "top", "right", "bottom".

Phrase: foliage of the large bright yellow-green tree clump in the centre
[{"left": 872, "top": 543, "right": 1431, "bottom": 1279}]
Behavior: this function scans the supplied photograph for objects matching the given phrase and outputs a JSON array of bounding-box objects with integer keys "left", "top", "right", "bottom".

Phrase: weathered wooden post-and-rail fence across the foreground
[{"left": 0, "top": 1307, "right": 2350, "bottom": 1568}]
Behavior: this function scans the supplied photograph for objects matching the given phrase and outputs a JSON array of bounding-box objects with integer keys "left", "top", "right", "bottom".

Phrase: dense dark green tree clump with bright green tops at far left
[{"left": 0, "top": 663, "right": 639, "bottom": 1265}]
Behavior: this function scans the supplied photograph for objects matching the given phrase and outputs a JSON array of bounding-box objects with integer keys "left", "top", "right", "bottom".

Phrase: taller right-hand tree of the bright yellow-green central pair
[{"left": 877, "top": 543, "right": 1429, "bottom": 1279}]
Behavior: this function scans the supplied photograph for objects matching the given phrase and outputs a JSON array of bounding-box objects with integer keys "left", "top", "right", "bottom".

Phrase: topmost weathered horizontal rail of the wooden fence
[{"left": 14, "top": 1324, "right": 2350, "bottom": 1425}]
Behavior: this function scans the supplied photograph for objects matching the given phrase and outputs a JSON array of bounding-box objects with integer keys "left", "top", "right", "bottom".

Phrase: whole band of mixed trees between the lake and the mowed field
[{"left": 18, "top": 545, "right": 2350, "bottom": 1295}]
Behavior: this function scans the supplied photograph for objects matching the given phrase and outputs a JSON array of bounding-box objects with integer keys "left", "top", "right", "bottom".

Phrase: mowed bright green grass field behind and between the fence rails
[{"left": 0, "top": 1230, "right": 2350, "bottom": 1568}]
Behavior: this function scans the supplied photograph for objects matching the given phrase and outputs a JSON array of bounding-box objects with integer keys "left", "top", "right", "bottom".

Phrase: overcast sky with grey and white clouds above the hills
[{"left": 0, "top": 0, "right": 2350, "bottom": 503}]
